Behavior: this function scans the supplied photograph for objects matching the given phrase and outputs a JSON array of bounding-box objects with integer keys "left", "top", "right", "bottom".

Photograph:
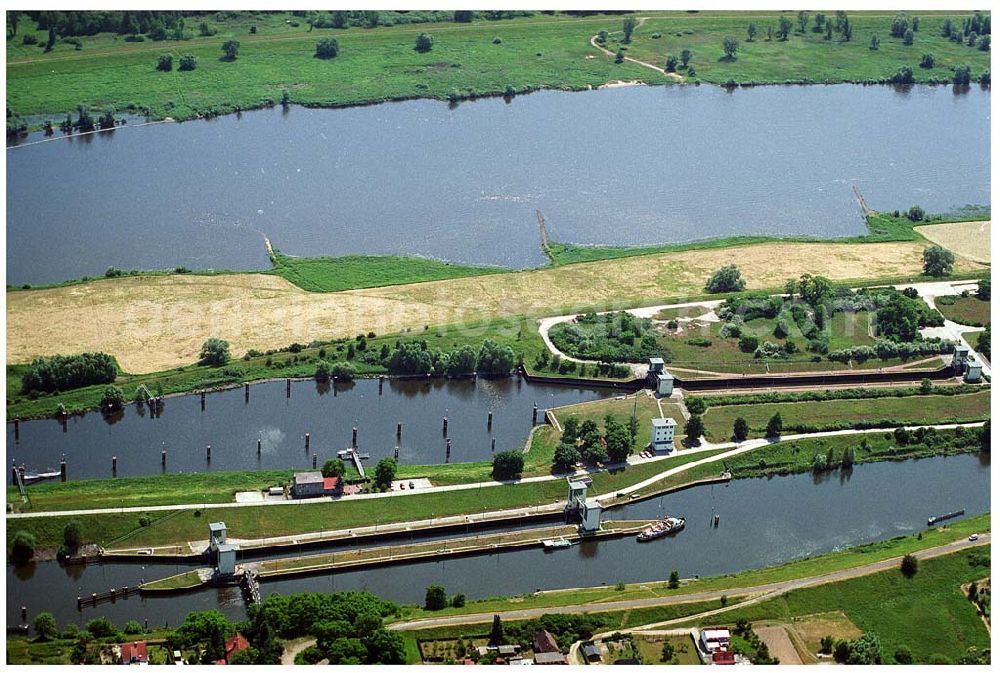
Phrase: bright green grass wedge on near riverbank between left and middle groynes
[{"left": 271, "top": 252, "right": 509, "bottom": 292}]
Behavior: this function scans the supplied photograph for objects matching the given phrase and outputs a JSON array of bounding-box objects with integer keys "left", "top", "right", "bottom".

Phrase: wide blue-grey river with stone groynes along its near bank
[{"left": 7, "top": 85, "right": 990, "bottom": 284}]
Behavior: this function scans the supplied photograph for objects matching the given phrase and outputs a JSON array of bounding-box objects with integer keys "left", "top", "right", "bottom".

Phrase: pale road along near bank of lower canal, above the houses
[{"left": 389, "top": 533, "right": 990, "bottom": 631}]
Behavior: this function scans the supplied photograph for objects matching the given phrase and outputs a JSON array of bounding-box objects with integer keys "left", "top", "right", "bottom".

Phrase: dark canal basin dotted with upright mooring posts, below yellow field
[{"left": 7, "top": 377, "right": 617, "bottom": 483}]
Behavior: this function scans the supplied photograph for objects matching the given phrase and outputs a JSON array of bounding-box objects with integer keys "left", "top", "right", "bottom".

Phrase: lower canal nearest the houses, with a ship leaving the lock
[{"left": 7, "top": 448, "right": 990, "bottom": 626}]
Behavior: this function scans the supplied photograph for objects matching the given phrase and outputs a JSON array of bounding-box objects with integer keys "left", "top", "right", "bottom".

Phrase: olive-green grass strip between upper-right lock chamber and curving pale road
[{"left": 704, "top": 390, "right": 990, "bottom": 441}]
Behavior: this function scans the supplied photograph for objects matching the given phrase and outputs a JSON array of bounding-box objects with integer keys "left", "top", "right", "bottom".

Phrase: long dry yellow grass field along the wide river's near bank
[{"left": 7, "top": 242, "right": 982, "bottom": 373}]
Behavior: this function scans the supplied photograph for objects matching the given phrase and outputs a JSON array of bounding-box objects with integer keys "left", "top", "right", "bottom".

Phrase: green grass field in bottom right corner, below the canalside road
[{"left": 676, "top": 548, "right": 990, "bottom": 663}]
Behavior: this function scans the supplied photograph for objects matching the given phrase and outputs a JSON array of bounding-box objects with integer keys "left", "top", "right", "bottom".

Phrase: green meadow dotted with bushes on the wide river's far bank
[{"left": 7, "top": 12, "right": 989, "bottom": 121}]
